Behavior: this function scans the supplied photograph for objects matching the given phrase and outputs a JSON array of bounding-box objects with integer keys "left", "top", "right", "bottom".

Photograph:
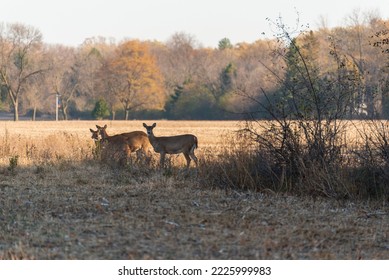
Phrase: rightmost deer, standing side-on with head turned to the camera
[{"left": 143, "top": 123, "right": 198, "bottom": 168}]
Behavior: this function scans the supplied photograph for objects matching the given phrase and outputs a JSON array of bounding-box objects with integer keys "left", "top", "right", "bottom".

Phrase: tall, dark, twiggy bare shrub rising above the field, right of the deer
[{"left": 229, "top": 16, "right": 357, "bottom": 197}]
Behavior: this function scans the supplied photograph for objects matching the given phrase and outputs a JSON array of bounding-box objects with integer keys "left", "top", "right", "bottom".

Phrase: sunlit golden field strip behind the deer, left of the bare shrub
[{"left": 0, "top": 121, "right": 239, "bottom": 165}]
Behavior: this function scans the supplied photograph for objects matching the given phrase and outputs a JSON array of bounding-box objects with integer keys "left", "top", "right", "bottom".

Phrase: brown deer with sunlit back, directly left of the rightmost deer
[{"left": 91, "top": 125, "right": 152, "bottom": 162}]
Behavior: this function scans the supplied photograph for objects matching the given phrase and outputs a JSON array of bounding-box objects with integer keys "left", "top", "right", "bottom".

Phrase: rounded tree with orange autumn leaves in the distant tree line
[{"left": 106, "top": 40, "right": 165, "bottom": 120}]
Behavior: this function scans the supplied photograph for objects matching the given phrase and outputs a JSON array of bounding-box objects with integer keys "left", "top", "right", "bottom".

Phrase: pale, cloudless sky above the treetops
[{"left": 0, "top": 0, "right": 389, "bottom": 47}]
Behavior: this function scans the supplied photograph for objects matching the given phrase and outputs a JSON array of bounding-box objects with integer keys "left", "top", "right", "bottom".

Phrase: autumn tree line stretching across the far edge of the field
[{"left": 0, "top": 12, "right": 389, "bottom": 121}]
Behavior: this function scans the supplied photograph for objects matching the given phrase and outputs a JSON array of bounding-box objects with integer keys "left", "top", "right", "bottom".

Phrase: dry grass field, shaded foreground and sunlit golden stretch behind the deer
[{"left": 0, "top": 121, "right": 389, "bottom": 259}]
